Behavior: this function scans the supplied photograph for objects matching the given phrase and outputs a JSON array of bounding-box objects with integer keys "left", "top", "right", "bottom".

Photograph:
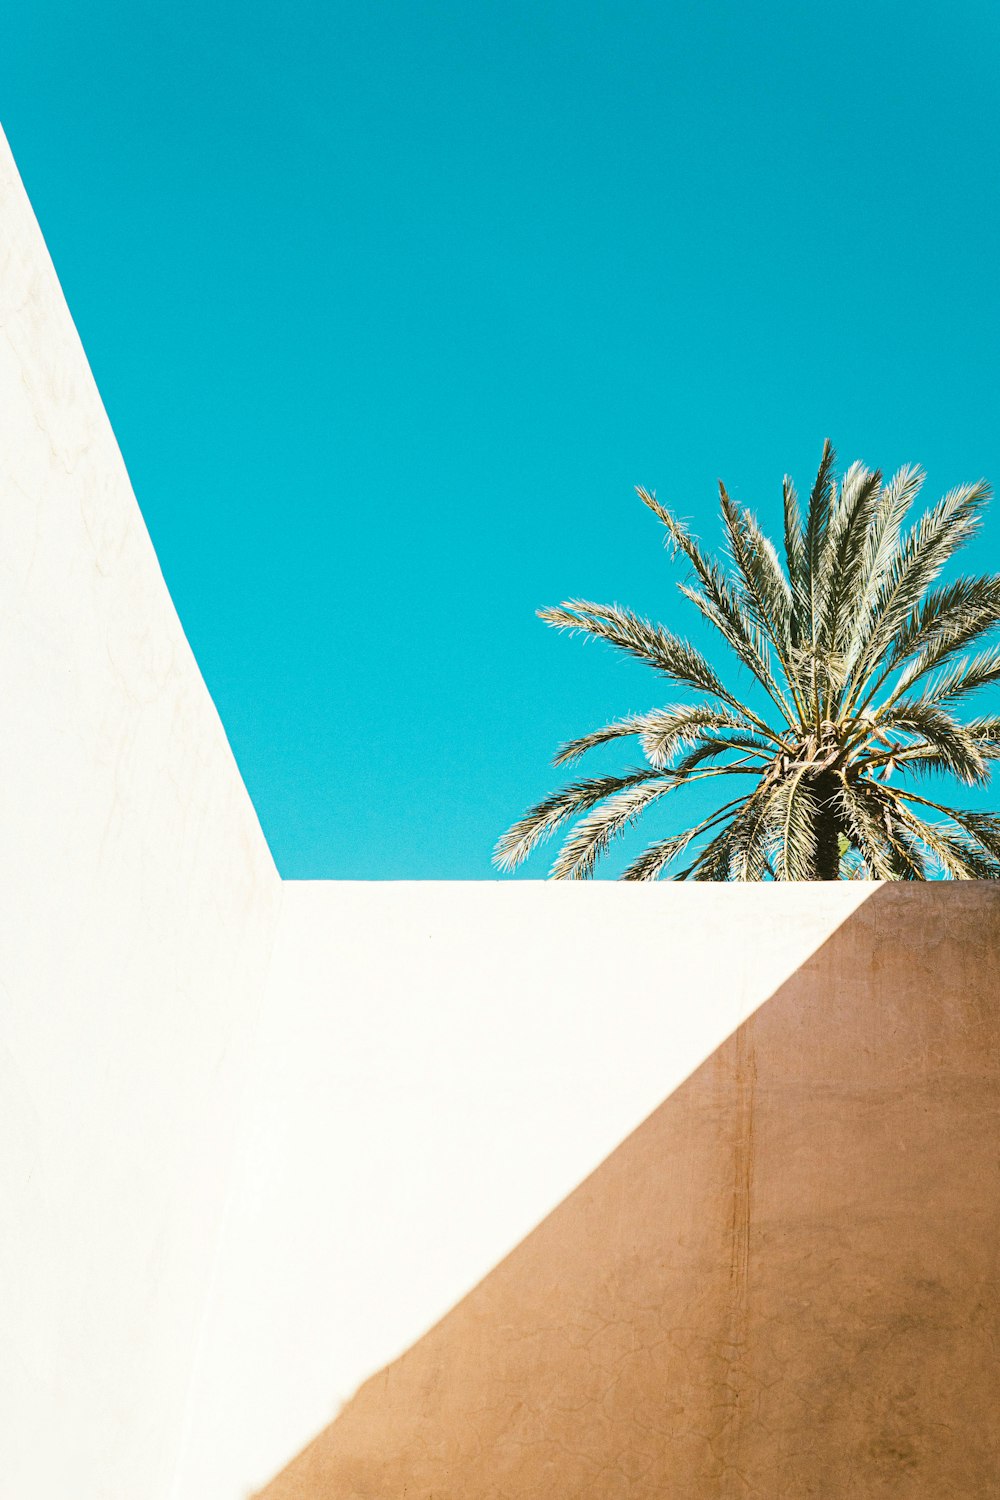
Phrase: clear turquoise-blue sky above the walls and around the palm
[{"left": 0, "top": 0, "right": 1000, "bottom": 879}]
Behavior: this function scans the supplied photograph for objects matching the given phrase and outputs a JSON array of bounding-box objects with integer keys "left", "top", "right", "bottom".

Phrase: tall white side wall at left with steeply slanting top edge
[{"left": 0, "top": 126, "right": 280, "bottom": 1500}]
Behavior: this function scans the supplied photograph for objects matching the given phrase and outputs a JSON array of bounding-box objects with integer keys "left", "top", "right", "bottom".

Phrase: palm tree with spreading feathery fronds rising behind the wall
[{"left": 495, "top": 443, "right": 1000, "bottom": 881}]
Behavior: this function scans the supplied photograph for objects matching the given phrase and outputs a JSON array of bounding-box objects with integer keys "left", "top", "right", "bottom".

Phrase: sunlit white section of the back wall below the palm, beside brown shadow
[{"left": 175, "top": 882, "right": 876, "bottom": 1500}]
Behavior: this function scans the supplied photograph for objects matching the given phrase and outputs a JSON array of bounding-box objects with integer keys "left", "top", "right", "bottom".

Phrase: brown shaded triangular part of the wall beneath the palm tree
[{"left": 262, "top": 885, "right": 1000, "bottom": 1500}]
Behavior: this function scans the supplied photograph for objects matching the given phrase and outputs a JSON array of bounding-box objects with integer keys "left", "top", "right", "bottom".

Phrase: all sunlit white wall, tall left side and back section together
[{"left": 0, "top": 126, "right": 870, "bottom": 1500}]
